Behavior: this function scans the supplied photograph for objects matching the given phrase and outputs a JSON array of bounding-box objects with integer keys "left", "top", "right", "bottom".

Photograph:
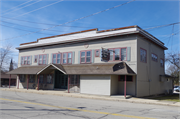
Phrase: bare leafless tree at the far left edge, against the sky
[{"left": 0, "top": 44, "right": 12, "bottom": 70}]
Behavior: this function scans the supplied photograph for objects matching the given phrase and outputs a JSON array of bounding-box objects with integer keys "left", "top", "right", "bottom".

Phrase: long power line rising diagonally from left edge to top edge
[{"left": 1, "top": 0, "right": 135, "bottom": 41}]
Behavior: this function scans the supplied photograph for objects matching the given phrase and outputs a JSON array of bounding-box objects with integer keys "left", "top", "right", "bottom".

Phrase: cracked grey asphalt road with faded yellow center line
[{"left": 0, "top": 91, "right": 180, "bottom": 119}]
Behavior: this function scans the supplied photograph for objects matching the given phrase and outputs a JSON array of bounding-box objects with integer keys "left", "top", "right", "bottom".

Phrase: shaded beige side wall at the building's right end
[{"left": 137, "top": 37, "right": 172, "bottom": 97}]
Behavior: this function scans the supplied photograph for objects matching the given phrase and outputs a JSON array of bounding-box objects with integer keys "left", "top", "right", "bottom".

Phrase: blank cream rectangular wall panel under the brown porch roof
[{"left": 80, "top": 75, "right": 111, "bottom": 96}]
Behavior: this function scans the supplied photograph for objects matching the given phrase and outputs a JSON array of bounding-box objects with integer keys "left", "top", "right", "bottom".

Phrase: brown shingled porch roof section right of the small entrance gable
[{"left": 63, "top": 62, "right": 135, "bottom": 75}]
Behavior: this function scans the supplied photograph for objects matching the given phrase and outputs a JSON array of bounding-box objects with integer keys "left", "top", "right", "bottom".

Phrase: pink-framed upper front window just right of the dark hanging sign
[{"left": 109, "top": 48, "right": 127, "bottom": 61}]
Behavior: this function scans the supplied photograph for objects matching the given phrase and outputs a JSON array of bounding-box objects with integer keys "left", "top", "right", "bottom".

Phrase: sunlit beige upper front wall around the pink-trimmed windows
[{"left": 18, "top": 35, "right": 137, "bottom": 72}]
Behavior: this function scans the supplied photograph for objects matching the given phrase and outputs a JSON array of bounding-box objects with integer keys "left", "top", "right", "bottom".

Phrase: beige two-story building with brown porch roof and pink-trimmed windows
[{"left": 8, "top": 26, "right": 173, "bottom": 97}]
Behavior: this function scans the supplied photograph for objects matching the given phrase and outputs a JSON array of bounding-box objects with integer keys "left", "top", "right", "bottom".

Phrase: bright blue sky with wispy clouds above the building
[{"left": 0, "top": 0, "right": 180, "bottom": 68}]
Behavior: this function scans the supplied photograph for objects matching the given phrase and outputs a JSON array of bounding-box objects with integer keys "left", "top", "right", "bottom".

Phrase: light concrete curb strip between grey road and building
[{"left": 1, "top": 88, "right": 180, "bottom": 107}]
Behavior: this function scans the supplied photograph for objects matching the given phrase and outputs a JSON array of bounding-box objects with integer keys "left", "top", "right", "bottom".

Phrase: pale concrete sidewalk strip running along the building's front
[{"left": 0, "top": 88, "right": 180, "bottom": 107}]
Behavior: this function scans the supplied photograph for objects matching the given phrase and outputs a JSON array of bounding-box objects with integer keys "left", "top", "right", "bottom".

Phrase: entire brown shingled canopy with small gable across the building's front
[{"left": 7, "top": 62, "right": 135, "bottom": 75}]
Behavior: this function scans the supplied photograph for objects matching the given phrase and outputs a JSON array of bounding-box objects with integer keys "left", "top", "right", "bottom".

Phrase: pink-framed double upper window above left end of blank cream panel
[{"left": 80, "top": 50, "right": 91, "bottom": 63}]
